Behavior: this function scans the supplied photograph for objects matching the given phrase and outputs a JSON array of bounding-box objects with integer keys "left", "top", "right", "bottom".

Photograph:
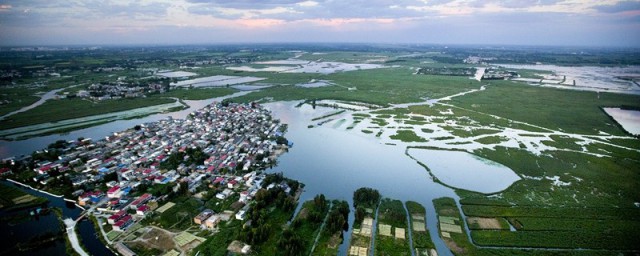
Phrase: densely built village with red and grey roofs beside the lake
[{"left": 26, "top": 102, "right": 293, "bottom": 255}]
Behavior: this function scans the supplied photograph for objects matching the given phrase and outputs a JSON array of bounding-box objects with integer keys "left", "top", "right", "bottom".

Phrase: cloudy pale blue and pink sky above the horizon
[{"left": 0, "top": 0, "right": 640, "bottom": 47}]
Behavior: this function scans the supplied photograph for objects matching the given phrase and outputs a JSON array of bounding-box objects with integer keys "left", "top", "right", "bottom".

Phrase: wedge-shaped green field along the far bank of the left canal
[{"left": 0, "top": 97, "right": 174, "bottom": 130}]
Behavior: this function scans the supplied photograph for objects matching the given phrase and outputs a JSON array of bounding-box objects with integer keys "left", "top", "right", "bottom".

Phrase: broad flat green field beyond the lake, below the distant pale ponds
[{"left": 231, "top": 68, "right": 479, "bottom": 105}]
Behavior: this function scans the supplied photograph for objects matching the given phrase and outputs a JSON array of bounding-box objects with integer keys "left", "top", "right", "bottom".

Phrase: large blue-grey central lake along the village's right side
[{"left": 267, "top": 102, "right": 458, "bottom": 255}]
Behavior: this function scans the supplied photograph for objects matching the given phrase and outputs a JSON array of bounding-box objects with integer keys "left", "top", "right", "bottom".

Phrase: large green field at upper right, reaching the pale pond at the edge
[{"left": 451, "top": 81, "right": 640, "bottom": 135}]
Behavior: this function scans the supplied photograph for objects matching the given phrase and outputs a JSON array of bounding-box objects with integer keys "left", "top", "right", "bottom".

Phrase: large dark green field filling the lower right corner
[{"left": 450, "top": 143, "right": 640, "bottom": 250}]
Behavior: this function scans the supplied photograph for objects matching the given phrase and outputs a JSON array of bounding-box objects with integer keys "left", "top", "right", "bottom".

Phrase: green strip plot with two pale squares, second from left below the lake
[{"left": 374, "top": 198, "right": 411, "bottom": 255}]
